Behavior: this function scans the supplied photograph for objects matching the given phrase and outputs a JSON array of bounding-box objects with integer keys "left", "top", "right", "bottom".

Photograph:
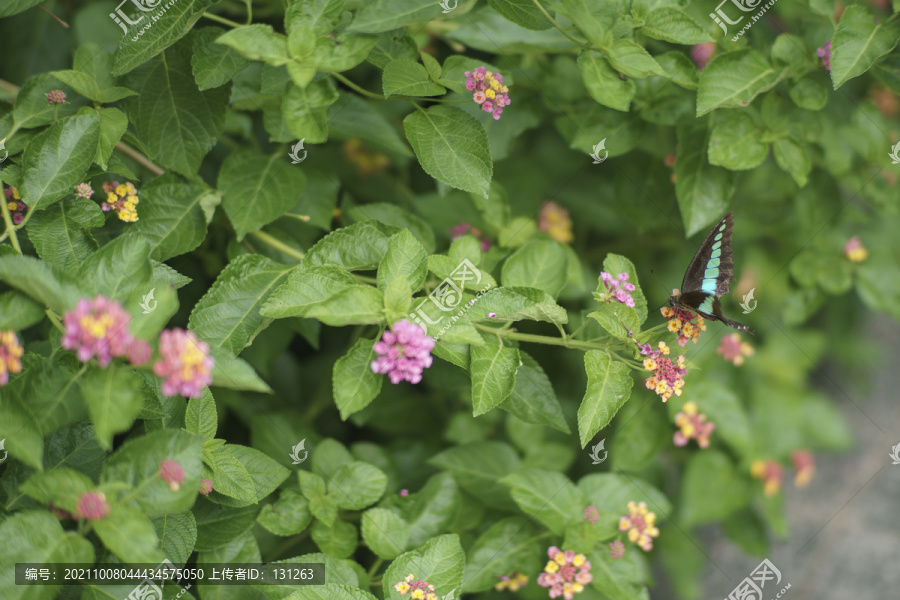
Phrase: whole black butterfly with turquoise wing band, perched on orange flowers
[{"left": 669, "top": 213, "right": 756, "bottom": 335}]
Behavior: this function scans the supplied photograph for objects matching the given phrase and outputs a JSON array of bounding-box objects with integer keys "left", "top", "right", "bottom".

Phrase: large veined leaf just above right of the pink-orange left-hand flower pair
[{"left": 188, "top": 252, "right": 290, "bottom": 354}]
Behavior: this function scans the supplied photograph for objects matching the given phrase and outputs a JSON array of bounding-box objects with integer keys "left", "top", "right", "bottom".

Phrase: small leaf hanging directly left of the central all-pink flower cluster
[{"left": 332, "top": 339, "right": 384, "bottom": 421}]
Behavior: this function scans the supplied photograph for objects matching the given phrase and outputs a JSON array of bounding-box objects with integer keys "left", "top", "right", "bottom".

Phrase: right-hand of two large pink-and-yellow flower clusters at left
[{"left": 153, "top": 327, "right": 215, "bottom": 398}]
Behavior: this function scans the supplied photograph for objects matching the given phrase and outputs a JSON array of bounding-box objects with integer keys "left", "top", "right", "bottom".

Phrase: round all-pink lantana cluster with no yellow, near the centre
[{"left": 370, "top": 319, "right": 434, "bottom": 384}]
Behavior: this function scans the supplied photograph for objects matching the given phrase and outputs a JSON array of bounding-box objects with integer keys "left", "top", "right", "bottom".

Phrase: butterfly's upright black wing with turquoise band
[{"left": 681, "top": 213, "right": 734, "bottom": 298}]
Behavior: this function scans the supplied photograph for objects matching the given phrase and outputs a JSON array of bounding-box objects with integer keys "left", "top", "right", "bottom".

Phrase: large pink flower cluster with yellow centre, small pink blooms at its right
[{"left": 61, "top": 295, "right": 152, "bottom": 367}]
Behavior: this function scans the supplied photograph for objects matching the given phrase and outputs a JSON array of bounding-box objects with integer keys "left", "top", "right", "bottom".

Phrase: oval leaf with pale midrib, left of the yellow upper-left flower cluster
[{"left": 19, "top": 111, "right": 100, "bottom": 209}]
